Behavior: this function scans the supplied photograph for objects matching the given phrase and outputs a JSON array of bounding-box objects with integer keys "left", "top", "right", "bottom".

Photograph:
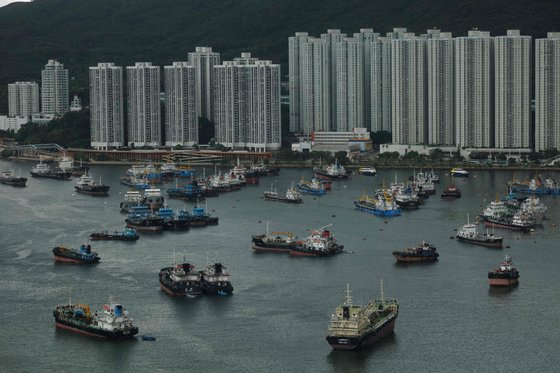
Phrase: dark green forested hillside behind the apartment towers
[{"left": 0, "top": 0, "right": 560, "bottom": 113}]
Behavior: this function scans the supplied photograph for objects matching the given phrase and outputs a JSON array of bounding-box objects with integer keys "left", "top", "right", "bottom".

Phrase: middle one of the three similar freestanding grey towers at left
[{"left": 126, "top": 62, "right": 161, "bottom": 146}]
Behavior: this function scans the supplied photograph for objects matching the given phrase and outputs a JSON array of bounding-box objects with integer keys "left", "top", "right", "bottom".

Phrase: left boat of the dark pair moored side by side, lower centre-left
[{"left": 159, "top": 263, "right": 202, "bottom": 298}]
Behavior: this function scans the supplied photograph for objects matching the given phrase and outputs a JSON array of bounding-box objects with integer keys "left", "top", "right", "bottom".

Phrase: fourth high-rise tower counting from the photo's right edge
[{"left": 426, "top": 29, "right": 455, "bottom": 145}]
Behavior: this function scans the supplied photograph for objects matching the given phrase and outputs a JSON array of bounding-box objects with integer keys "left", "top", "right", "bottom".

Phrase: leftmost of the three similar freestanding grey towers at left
[{"left": 89, "top": 63, "right": 125, "bottom": 149}]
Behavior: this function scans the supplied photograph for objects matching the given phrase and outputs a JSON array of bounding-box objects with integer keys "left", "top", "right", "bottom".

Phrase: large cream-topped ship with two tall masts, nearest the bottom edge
[{"left": 326, "top": 281, "right": 399, "bottom": 350}]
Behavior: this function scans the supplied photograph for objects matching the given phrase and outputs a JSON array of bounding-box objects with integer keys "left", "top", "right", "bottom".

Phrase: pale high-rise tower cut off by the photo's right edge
[{"left": 535, "top": 32, "right": 560, "bottom": 151}]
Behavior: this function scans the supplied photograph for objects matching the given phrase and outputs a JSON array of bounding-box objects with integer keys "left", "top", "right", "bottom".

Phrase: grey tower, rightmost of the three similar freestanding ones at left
[{"left": 163, "top": 62, "right": 198, "bottom": 146}]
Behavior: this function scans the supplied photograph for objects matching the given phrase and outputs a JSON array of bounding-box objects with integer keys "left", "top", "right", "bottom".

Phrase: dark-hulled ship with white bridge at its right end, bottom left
[{"left": 53, "top": 302, "right": 138, "bottom": 339}]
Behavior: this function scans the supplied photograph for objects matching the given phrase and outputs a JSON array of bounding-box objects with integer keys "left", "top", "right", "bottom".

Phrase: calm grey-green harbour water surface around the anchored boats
[{"left": 0, "top": 162, "right": 560, "bottom": 372}]
